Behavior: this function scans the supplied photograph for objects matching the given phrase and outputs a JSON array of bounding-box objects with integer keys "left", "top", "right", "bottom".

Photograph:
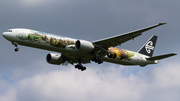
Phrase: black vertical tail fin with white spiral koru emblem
[{"left": 138, "top": 35, "right": 157, "bottom": 57}]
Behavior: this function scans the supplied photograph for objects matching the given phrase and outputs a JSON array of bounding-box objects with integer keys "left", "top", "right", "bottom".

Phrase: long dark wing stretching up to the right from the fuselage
[{"left": 93, "top": 23, "right": 166, "bottom": 48}]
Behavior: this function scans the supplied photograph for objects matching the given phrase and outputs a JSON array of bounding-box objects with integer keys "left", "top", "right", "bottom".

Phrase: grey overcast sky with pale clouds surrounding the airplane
[{"left": 0, "top": 0, "right": 180, "bottom": 101}]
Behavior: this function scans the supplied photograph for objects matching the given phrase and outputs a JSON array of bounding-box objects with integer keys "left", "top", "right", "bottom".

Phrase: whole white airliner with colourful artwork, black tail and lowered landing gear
[{"left": 2, "top": 23, "right": 177, "bottom": 71}]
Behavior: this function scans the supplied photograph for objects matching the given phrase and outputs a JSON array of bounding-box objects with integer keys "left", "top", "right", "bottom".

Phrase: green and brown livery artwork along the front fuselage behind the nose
[{"left": 16, "top": 32, "right": 75, "bottom": 48}]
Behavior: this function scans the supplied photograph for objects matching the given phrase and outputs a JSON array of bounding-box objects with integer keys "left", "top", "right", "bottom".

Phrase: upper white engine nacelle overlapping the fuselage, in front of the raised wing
[{"left": 75, "top": 40, "right": 95, "bottom": 53}]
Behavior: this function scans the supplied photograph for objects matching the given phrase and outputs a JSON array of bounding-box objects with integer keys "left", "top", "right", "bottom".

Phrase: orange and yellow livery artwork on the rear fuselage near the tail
[{"left": 108, "top": 47, "right": 134, "bottom": 60}]
